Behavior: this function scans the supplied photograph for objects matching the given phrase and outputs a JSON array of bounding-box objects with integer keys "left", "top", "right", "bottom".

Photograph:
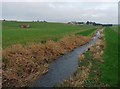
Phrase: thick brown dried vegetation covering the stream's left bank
[{"left": 2, "top": 36, "right": 91, "bottom": 87}]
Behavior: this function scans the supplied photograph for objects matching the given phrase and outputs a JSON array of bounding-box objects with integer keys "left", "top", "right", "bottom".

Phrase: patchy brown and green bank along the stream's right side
[{"left": 57, "top": 30, "right": 109, "bottom": 88}]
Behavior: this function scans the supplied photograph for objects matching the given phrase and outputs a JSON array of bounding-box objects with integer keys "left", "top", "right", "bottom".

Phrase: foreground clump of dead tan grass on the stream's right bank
[{"left": 61, "top": 63, "right": 92, "bottom": 87}]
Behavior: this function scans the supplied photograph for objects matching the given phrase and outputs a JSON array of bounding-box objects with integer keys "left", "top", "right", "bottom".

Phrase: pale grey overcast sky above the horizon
[{"left": 2, "top": 0, "right": 118, "bottom": 24}]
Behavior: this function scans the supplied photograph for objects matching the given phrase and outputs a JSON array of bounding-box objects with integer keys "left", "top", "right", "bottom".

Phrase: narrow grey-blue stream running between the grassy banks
[{"left": 31, "top": 31, "right": 98, "bottom": 87}]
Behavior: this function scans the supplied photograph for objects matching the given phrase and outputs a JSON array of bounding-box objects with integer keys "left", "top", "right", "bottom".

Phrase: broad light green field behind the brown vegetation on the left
[{"left": 2, "top": 21, "right": 96, "bottom": 48}]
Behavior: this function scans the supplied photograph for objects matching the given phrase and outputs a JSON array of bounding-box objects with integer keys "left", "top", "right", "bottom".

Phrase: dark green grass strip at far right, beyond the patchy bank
[{"left": 101, "top": 28, "right": 118, "bottom": 87}]
